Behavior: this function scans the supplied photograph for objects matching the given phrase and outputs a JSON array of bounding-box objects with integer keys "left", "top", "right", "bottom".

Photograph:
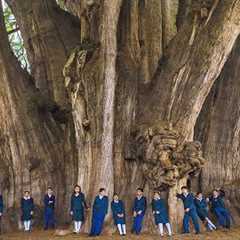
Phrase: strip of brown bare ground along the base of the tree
[{"left": 0, "top": 227, "right": 240, "bottom": 240}]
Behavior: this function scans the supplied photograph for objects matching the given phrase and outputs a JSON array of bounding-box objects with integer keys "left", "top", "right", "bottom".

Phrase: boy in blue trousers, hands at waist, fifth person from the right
[{"left": 132, "top": 188, "right": 147, "bottom": 235}]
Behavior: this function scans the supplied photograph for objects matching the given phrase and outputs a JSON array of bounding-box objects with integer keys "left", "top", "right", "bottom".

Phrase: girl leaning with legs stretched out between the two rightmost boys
[{"left": 194, "top": 192, "right": 216, "bottom": 231}]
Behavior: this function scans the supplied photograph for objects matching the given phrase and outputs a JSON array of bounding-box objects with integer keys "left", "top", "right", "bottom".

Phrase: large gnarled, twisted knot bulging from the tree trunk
[{"left": 125, "top": 125, "right": 205, "bottom": 189}]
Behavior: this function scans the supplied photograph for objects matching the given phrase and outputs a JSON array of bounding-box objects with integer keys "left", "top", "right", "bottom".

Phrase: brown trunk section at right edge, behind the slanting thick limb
[{"left": 195, "top": 35, "right": 240, "bottom": 223}]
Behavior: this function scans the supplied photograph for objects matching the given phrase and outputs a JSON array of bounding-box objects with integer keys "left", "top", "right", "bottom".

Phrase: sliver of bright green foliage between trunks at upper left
[{"left": 2, "top": 0, "right": 30, "bottom": 71}]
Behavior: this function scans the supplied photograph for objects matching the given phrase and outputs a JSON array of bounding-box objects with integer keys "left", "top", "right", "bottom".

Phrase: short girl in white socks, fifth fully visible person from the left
[{"left": 111, "top": 193, "right": 126, "bottom": 236}]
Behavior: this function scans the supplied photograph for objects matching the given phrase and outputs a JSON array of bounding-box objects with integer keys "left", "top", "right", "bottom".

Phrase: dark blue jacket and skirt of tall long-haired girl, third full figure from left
[{"left": 71, "top": 192, "right": 87, "bottom": 221}]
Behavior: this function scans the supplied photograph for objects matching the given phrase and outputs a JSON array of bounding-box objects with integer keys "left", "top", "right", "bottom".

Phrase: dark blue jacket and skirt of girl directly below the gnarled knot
[{"left": 152, "top": 198, "right": 169, "bottom": 225}]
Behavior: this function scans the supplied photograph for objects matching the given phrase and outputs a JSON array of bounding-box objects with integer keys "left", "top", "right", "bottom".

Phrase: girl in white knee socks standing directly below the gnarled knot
[{"left": 152, "top": 192, "right": 172, "bottom": 236}]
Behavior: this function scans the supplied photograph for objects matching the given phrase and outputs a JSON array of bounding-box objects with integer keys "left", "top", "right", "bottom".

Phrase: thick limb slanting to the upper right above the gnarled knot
[{"left": 139, "top": 0, "right": 240, "bottom": 141}]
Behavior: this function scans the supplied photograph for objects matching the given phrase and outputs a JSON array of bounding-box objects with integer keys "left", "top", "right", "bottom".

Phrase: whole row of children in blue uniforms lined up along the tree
[{"left": 0, "top": 185, "right": 231, "bottom": 236}]
